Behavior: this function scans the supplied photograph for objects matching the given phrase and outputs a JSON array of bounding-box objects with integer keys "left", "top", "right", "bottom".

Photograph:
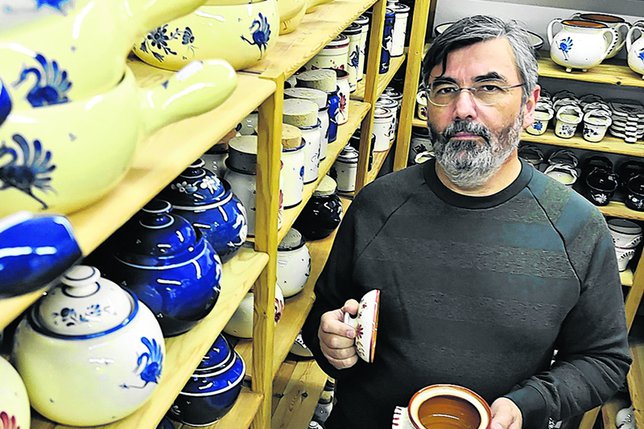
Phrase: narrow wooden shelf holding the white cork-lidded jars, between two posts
[{"left": 277, "top": 100, "right": 370, "bottom": 243}]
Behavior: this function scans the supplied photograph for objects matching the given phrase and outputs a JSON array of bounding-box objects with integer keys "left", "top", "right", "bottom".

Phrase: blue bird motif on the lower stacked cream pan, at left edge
[{"left": 0, "top": 134, "right": 56, "bottom": 210}]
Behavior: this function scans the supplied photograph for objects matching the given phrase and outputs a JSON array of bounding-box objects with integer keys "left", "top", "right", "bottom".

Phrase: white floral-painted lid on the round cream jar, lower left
[{"left": 34, "top": 265, "right": 135, "bottom": 336}]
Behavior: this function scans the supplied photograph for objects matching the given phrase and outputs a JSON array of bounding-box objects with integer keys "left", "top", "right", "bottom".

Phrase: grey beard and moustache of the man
[{"left": 429, "top": 108, "right": 523, "bottom": 189}]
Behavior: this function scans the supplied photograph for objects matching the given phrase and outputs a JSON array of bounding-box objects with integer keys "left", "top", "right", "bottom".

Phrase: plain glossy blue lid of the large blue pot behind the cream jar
[{"left": 115, "top": 199, "right": 205, "bottom": 267}]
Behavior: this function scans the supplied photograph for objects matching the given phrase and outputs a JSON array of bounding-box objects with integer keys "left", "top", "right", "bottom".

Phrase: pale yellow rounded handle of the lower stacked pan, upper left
[{"left": 139, "top": 60, "right": 237, "bottom": 136}]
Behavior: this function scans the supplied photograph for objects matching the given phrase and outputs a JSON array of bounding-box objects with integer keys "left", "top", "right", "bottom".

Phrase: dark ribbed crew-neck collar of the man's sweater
[{"left": 423, "top": 159, "right": 533, "bottom": 209}]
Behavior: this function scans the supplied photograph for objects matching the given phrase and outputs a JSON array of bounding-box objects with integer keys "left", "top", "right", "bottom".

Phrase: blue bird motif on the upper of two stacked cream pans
[{"left": 13, "top": 54, "right": 72, "bottom": 107}]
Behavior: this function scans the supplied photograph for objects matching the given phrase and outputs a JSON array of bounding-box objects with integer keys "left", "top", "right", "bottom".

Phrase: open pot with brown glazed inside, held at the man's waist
[{"left": 407, "top": 384, "right": 492, "bottom": 429}]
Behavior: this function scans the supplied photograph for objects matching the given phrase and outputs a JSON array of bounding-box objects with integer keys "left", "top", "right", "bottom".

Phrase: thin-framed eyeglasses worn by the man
[{"left": 427, "top": 82, "right": 524, "bottom": 107}]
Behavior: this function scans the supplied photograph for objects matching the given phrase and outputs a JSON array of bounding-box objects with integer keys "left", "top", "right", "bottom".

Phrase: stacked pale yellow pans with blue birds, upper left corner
[{"left": 0, "top": 0, "right": 236, "bottom": 217}]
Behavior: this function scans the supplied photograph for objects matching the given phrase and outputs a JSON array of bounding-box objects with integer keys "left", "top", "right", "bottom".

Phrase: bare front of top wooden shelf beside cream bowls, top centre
[{"left": 244, "top": 0, "right": 375, "bottom": 78}]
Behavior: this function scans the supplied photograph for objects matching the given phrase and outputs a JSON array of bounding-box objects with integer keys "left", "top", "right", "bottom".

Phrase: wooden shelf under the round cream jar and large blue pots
[{"left": 31, "top": 248, "right": 268, "bottom": 429}]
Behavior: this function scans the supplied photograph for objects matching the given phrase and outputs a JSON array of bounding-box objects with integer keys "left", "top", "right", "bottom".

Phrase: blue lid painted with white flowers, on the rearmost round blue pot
[{"left": 161, "top": 158, "right": 226, "bottom": 207}]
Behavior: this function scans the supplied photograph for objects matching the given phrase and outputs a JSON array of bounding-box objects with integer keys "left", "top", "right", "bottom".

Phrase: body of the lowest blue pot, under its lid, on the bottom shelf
[{"left": 169, "top": 352, "right": 246, "bottom": 426}]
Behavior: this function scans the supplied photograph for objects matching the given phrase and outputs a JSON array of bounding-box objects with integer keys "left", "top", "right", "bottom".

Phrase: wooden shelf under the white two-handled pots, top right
[{"left": 538, "top": 53, "right": 644, "bottom": 88}]
